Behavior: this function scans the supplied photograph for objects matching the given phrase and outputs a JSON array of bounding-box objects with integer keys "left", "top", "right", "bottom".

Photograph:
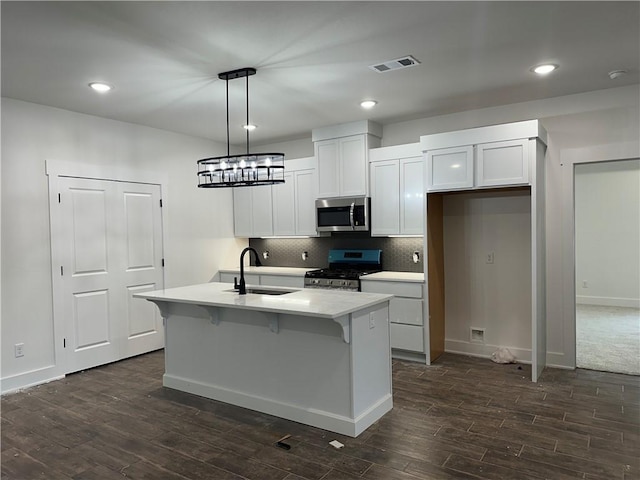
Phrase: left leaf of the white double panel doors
[{"left": 60, "top": 178, "right": 124, "bottom": 372}]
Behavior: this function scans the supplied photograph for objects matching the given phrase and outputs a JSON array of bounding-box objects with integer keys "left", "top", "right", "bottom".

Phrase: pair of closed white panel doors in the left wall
[{"left": 57, "top": 177, "right": 164, "bottom": 373}]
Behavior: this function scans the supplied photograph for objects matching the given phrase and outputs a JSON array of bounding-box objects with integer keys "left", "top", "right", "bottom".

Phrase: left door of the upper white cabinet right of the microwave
[{"left": 370, "top": 160, "right": 400, "bottom": 235}]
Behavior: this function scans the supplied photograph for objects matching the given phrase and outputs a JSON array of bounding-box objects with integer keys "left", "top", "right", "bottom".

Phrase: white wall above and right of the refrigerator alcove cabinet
[{"left": 263, "top": 82, "right": 640, "bottom": 367}]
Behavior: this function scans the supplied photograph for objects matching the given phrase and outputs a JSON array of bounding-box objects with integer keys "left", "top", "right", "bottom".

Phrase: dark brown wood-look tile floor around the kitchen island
[{"left": 1, "top": 351, "right": 640, "bottom": 480}]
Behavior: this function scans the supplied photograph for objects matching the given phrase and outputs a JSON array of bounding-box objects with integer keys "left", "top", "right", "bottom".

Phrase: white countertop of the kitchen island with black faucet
[{"left": 134, "top": 282, "right": 393, "bottom": 319}]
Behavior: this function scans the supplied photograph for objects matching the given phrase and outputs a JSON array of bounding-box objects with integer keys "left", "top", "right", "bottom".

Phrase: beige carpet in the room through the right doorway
[{"left": 576, "top": 305, "right": 640, "bottom": 375}]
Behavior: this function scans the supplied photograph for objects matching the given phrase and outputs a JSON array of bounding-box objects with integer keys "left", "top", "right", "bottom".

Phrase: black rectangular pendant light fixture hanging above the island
[{"left": 198, "top": 68, "right": 284, "bottom": 188}]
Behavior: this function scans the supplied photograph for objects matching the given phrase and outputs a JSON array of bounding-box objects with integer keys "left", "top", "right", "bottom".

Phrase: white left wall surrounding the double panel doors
[{"left": 1, "top": 98, "right": 246, "bottom": 391}]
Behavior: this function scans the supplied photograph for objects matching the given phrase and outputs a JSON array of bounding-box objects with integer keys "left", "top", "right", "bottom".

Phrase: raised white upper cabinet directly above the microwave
[{"left": 312, "top": 120, "right": 382, "bottom": 198}]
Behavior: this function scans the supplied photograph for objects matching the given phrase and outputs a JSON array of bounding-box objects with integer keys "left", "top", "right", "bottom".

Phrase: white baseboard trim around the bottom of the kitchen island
[{"left": 163, "top": 374, "right": 393, "bottom": 437}]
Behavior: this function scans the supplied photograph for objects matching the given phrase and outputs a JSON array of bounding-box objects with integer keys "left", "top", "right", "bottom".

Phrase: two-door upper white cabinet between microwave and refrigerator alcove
[{"left": 369, "top": 143, "right": 424, "bottom": 236}]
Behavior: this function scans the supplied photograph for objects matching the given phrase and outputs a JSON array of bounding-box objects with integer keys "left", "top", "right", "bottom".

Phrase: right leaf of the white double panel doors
[{"left": 115, "top": 183, "right": 164, "bottom": 358}]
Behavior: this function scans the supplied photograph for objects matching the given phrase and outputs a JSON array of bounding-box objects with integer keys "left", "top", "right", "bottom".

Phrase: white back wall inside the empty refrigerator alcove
[{"left": 443, "top": 191, "right": 531, "bottom": 361}]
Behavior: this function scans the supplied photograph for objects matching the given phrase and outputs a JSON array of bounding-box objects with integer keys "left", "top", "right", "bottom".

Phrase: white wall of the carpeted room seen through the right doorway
[{"left": 574, "top": 159, "right": 640, "bottom": 307}]
